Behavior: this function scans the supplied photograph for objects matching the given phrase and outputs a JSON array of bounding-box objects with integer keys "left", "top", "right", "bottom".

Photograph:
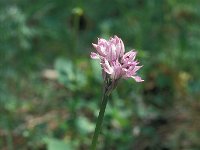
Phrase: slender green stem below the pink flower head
[{"left": 90, "top": 90, "right": 108, "bottom": 150}]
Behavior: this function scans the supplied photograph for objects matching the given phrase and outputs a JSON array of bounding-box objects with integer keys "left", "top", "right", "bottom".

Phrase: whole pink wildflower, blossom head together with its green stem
[{"left": 90, "top": 36, "right": 144, "bottom": 150}]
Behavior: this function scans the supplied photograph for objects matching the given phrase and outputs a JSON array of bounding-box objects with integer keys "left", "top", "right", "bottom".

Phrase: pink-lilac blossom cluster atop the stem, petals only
[{"left": 91, "top": 36, "right": 144, "bottom": 82}]
